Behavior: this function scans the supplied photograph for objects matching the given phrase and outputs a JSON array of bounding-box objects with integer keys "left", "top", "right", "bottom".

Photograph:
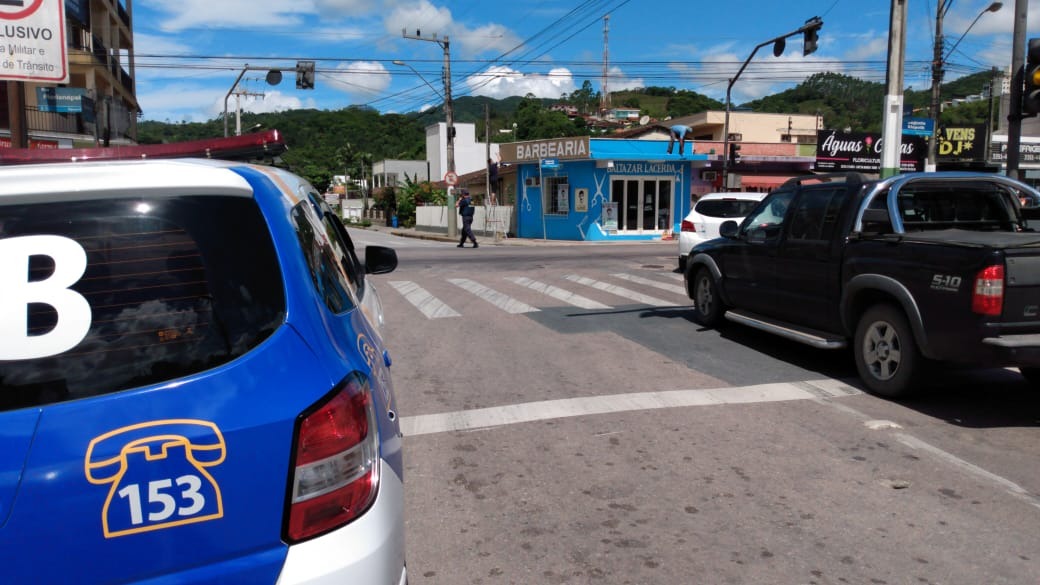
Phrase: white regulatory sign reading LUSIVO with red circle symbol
[{"left": 0, "top": 0, "right": 69, "bottom": 83}]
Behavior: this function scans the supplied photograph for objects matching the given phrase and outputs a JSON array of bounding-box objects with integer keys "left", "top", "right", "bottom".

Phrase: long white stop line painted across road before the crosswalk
[{"left": 400, "top": 383, "right": 817, "bottom": 436}]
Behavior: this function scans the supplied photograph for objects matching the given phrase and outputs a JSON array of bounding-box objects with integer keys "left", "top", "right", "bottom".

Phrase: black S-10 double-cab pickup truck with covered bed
[{"left": 684, "top": 172, "right": 1040, "bottom": 398}]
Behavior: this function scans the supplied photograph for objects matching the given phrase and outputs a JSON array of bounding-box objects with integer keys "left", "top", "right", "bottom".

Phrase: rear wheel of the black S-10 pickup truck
[{"left": 854, "top": 305, "right": 924, "bottom": 399}]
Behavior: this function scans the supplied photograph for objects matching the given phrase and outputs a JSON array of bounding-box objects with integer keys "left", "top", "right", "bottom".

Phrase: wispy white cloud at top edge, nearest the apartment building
[{"left": 148, "top": 0, "right": 315, "bottom": 31}]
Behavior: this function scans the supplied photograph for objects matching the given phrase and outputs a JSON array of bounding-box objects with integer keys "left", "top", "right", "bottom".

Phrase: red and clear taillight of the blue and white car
[{"left": 286, "top": 373, "right": 380, "bottom": 542}]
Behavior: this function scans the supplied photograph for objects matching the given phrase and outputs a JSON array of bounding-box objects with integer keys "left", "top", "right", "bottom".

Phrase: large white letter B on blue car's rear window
[{"left": 0, "top": 235, "right": 90, "bottom": 359}]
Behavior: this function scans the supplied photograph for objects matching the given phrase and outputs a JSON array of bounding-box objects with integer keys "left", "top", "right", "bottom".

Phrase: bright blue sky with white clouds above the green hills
[{"left": 133, "top": 0, "right": 1040, "bottom": 122}]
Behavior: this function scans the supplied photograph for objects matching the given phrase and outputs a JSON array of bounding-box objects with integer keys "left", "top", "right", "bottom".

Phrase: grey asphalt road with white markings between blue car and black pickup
[{"left": 355, "top": 231, "right": 1040, "bottom": 585}]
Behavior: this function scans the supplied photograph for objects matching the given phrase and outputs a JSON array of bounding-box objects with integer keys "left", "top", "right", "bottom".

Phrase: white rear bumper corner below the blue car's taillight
[{"left": 278, "top": 460, "right": 408, "bottom": 585}]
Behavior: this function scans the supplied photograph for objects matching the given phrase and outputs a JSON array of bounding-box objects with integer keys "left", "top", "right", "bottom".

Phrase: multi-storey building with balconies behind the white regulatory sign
[{"left": 0, "top": 0, "right": 140, "bottom": 148}]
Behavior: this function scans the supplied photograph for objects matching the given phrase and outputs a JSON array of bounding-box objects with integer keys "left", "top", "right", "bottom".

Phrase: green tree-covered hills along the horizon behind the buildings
[{"left": 138, "top": 72, "right": 990, "bottom": 188}]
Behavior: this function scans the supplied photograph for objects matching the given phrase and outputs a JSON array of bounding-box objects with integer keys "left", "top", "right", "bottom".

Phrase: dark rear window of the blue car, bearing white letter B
[{"left": 0, "top": 197, "right": 285, "bottom": 410}]
